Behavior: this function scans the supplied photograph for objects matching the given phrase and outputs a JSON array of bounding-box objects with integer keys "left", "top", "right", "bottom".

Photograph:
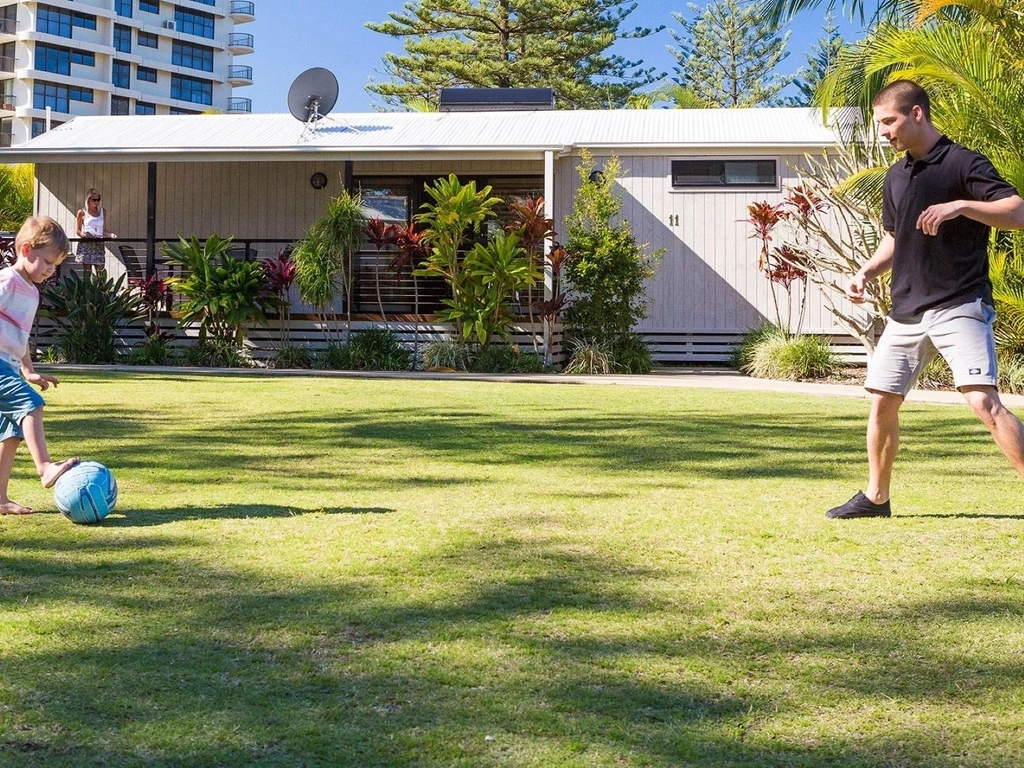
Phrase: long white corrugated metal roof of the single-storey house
[{"left": 0, "top": 108, "right": 837, "bottom": 163}]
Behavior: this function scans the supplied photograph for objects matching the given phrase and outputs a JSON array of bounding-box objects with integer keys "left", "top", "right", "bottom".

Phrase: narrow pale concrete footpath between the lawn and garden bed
[{"left": 59, "top": 365, "right": 1024, "bottom": 412}]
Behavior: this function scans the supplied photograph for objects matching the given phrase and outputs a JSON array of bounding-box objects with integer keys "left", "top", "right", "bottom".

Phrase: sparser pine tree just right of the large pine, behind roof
[{"left": 669, "top": 0, "right": 793, "bottom": 106}]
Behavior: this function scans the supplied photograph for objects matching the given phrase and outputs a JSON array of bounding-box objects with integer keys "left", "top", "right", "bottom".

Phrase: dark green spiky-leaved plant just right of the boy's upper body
[{"left": 39, "top": 271, "right": 144, "bottom": 364}]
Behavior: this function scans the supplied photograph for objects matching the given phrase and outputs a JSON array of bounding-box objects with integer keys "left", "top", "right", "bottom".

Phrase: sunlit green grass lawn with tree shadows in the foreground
[{"left": 0, "top": 372, "right": 1024, "bottom": 768}]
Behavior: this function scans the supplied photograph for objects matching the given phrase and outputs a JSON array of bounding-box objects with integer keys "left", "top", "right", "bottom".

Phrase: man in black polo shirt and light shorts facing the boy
[{"left": 825, "top": 80, "right": 1024, "bottom": 519}]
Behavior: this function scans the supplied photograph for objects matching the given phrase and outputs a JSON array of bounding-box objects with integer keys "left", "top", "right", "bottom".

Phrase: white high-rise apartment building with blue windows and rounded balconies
[{"left": 0, "top": 0, "right": 255, "bottom": 146}]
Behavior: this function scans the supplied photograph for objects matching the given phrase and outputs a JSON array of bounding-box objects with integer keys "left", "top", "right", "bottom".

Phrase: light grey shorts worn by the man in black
[{"left": 864, "top": 299, "right": 998, "bottom": 396}]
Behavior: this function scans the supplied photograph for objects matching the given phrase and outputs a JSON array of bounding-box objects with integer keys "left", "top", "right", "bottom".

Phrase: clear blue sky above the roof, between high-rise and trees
[{"left": 241, "top": 0, "right": 872, "bottom": 113}]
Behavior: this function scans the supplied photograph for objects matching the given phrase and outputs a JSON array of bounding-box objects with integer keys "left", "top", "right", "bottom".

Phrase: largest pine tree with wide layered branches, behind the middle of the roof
[{"left": 367, "top": 0, "right": 664, "bottom": 110}]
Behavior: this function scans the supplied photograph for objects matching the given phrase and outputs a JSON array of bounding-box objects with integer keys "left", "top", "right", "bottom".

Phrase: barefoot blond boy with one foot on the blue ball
[{"left": 0, "top": 216, "right": 79, "bottom": 515}]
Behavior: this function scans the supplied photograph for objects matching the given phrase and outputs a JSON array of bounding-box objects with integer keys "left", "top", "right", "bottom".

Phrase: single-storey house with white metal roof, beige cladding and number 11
[{"left": 0, "top": 109, "right": 855, "bottom": 361}]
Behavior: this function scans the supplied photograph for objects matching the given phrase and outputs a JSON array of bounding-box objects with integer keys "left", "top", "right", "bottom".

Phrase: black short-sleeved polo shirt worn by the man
[{"left": 882, "top": 136, "right": 1017, "bottom": 321}]
